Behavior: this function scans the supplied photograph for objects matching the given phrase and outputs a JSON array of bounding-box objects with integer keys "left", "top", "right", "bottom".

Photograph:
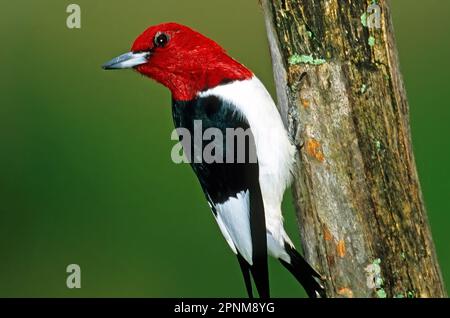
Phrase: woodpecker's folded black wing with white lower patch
[{"left": 172, "top": 96, "right": 270, "bottom": 297}]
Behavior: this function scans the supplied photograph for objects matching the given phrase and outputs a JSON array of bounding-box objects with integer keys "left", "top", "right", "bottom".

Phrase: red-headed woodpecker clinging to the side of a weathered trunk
[{"left": 102, "top": 22, "right": 325, "bottom": 299}]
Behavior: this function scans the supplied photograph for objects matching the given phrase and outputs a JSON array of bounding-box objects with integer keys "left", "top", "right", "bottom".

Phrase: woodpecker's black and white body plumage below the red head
[{"left": 172, "top": 76, "right": 322, "bottom": 297}]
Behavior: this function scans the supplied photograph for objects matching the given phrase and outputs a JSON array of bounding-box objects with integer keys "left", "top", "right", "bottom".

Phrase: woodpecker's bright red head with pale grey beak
[{"left": 104, "top": 23, "right": 253, "bottom": 100}]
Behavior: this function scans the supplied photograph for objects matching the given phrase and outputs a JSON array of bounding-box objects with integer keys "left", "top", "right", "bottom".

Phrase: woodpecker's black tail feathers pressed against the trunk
[{"left": 280, "top": 244, "right": 326, "bottom": 298}]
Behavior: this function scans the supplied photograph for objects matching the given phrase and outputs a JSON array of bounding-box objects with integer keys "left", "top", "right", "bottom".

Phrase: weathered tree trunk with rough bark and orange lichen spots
[{"left": 261, "top": 0, "right": 446, "bottom": 297}]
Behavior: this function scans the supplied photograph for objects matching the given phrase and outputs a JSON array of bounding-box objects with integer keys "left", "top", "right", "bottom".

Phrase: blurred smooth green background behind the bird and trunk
[{"left": 0, "top": 0, "right": 450, "bottom": 297}]
